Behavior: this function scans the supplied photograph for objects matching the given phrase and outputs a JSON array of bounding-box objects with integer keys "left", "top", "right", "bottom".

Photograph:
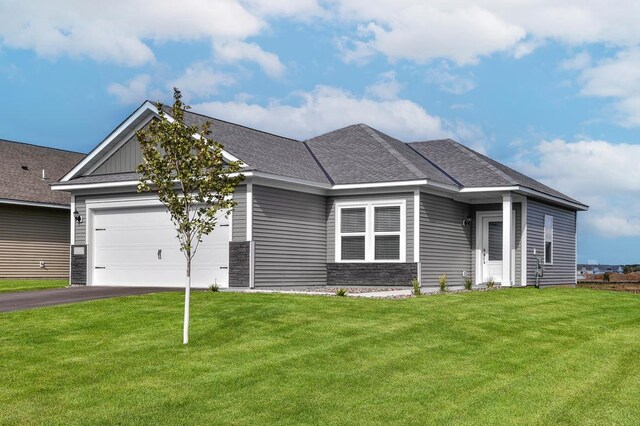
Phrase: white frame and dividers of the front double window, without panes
[{"left": 334, "top": 200, "right": 407, "bottom": 263}]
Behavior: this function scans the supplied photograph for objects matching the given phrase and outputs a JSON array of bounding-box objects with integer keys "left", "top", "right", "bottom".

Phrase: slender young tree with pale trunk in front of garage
[{"left": 136, "top": 88, "right": 244, "bottom": 344}]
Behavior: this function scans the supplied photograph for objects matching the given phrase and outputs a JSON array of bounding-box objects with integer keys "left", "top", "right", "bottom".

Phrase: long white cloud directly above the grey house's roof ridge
[{"left": 193, "top": 86, "right": 453, "bottom": 140}]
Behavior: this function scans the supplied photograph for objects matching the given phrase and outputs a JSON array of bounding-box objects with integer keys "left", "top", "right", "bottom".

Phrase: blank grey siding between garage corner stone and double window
[{"left": 252, "top": 185, "right": 327, "bottom": 287}]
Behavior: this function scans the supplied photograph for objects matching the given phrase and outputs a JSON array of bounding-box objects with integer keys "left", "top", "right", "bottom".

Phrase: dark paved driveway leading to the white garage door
[{"left": 0, "top": 286, "right": 180, "bottom": 312}]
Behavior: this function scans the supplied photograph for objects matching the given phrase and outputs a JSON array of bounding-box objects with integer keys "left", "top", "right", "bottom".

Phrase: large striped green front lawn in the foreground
[{"left": 0, "top": 289, "right": 640, "bottom": 425}]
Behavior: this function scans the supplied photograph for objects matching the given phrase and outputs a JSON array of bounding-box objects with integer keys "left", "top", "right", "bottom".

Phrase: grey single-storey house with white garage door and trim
[{"left": 53, "top": 102, "right": 587, "bottom": 287}]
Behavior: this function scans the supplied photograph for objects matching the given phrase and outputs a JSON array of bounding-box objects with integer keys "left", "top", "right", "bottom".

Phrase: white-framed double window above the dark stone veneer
[{"left": 336, "top": 201, "right": 406, "bottom": 262}]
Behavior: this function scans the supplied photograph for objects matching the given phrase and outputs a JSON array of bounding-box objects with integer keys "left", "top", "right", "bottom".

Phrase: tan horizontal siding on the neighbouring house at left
[{"left": 0, "top": 205, "right": 71, "bottom": 278}]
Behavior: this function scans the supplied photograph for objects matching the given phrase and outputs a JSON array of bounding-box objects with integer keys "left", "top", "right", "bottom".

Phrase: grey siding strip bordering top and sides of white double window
[{"left": 327, "top": 192, "right": 417, "bottom": 263}]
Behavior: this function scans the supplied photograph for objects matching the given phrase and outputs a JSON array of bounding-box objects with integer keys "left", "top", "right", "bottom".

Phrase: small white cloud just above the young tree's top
[{"left": 167, "top": 62, "right": 235, "bottom": 102}]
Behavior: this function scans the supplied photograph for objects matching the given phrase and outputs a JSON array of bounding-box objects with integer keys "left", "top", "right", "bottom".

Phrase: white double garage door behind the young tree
[{"left": 92, "top": 207, "right": 229, "bottom": 288}]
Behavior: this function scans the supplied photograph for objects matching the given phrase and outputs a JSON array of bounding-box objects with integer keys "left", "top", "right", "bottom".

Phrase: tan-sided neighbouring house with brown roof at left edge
[{"left": 0, "top": 140, "right": 84, "bottom": 278}]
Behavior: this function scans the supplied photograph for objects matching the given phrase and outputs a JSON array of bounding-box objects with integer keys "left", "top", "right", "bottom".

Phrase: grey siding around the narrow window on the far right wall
[{"left": 527, "top": 199, "right": 576, "bottom": 285}]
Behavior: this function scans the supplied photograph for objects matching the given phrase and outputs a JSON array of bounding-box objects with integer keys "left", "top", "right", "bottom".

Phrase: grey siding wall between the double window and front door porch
[{"left": 420, "top": 192, "right": 472, "bottom": 287}]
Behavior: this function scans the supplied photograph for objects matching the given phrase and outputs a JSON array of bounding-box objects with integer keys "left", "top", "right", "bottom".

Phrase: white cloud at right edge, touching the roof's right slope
[{"left": 516, "top": 139, "right": 640, "bottom": 238}]
